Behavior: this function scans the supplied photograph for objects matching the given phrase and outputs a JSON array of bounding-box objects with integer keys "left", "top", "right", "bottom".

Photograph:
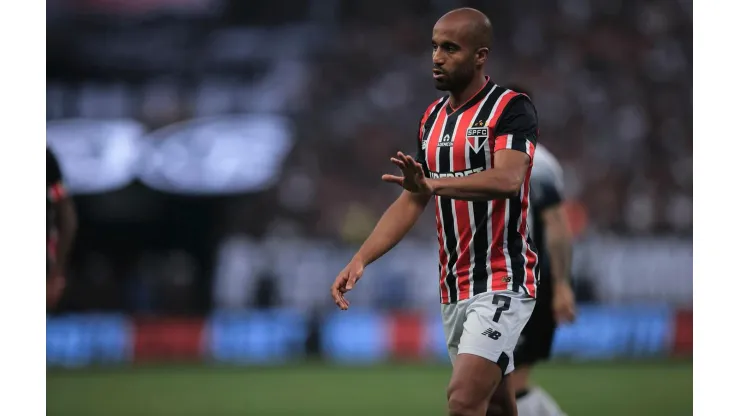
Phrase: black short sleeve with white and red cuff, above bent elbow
[{"left": 494, "top": 95, "right": 539, "bottom": 157}]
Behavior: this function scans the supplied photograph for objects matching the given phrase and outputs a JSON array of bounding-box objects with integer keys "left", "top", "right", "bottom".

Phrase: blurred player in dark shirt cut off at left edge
[{"left": 46, "top": 147, "right": 77, "bottom": 307}]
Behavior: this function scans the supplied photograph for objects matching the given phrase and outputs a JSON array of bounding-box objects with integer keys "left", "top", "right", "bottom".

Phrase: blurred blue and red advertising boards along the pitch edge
[{"left": 46, "top": 305, "right": 693, "bottom": 367}]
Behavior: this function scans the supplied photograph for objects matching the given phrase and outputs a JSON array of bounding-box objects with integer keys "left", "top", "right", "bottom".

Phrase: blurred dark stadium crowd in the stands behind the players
[{"left": 47, "top": 0, "right": 693, "bottom": 313}]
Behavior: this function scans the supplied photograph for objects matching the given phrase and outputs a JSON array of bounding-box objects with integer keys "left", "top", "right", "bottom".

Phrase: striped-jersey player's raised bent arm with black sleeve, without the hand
[{"left": 427, "top": 97, "right": 537, "bottom": 201}]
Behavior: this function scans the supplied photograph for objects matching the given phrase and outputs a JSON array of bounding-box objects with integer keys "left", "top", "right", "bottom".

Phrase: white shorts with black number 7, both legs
[{"left": 442, "top": 291, "right": 535, "bottom": 374}]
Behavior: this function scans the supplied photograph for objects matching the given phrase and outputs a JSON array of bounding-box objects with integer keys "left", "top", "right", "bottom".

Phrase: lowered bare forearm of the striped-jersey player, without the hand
[{"left": 353, "top": 190, "right": 430, "bottom": 267}]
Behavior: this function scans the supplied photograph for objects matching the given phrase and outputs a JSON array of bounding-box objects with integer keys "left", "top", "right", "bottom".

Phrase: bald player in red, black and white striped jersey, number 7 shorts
[{"left": 331, "top": 8, "right": 538, "bottom": 416}]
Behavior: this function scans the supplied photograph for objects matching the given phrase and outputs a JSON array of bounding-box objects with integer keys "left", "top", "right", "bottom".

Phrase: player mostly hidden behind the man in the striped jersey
[{"left": 510, "top": 87, "right": 576, "bottom": 416}]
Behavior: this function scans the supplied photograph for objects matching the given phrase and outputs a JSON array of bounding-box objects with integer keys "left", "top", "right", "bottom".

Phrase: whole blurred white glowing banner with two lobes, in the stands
[{"left": 46, "top": 114, "right": 293, "bottom": 195}]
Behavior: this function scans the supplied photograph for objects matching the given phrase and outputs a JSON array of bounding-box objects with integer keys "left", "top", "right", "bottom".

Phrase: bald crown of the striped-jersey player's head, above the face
[{"left": 434, "top": 7, "right": 493, "bottom": 49}]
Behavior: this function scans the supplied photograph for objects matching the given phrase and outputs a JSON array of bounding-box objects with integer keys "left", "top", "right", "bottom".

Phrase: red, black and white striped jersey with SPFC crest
[{"left": 417, "top": 80, "right": 539, "bottom": 304}]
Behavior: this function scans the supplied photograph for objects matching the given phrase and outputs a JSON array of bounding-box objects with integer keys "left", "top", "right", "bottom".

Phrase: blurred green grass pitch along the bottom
[{"left": 46, "top": 361, "right": 693, "bottom": 416}]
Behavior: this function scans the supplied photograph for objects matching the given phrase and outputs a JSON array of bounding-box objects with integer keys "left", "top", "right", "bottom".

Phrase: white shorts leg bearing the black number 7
[{"left": 458, "top": 291, "right": 535, "bottom": 375}]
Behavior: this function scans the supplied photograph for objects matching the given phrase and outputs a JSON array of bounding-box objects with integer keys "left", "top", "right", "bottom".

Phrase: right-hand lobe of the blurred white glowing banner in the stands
[{"left": 139, "top": 115, "right": 291, "bottom": 194}]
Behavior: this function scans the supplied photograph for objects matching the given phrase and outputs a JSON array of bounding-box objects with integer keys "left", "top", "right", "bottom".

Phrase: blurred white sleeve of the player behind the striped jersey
[{"left": 530, "top": 147, "right": 565, "bottom": 209}]
